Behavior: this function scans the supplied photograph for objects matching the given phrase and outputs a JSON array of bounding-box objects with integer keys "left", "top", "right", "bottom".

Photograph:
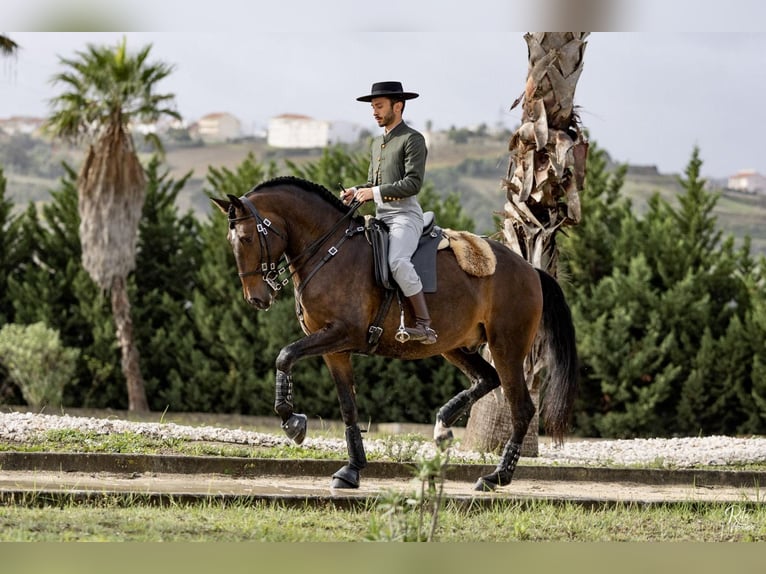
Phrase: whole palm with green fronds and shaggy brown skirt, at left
[{"left": 46, "top": 38, "right": 180, "bottom": 411}]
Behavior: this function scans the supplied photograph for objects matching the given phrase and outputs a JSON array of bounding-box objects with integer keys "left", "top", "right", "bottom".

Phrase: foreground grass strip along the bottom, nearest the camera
[{"left": 0, "top": 500, "right": 766, "bottom": 542}]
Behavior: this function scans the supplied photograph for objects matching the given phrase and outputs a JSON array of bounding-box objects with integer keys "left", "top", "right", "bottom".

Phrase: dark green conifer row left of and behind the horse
[{"left": 0, "top": 148, "right": 472, "bottom": 428}]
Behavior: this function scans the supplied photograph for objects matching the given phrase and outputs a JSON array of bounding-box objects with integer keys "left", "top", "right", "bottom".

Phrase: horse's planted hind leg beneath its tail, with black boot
[{"left": 474, "top": 351, "right": 535, "bottom": 491}]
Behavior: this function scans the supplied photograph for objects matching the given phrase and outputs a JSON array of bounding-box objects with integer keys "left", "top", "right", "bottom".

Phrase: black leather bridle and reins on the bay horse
[{"left": 229, "top": 195, "right": 364, "bottom": 295}]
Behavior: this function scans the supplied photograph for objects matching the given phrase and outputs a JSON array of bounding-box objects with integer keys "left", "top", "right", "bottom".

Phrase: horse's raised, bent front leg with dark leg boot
[{"left": 274, "top": 327, "right": 347, "bottom": 444}]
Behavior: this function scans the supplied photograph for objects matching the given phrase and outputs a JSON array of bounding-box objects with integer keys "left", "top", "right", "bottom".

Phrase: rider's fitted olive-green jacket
[{"left": 364, "top": 121, "right": 428, "bottom": 202}]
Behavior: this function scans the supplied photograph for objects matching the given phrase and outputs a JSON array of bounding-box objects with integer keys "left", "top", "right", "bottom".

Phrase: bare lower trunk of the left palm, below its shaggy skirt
[{"left": 111, "top": 277, "right": 149, "bottom": 412}]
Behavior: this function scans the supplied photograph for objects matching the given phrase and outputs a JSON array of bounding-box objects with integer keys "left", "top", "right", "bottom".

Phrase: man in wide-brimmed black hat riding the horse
[{"left": 341, "top": 82, "right": 437, "bottom": 345}]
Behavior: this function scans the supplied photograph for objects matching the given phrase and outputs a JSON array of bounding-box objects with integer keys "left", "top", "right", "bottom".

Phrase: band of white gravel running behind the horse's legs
[{"left": 0, "top": 412, "right": 766, "bottom": 468}]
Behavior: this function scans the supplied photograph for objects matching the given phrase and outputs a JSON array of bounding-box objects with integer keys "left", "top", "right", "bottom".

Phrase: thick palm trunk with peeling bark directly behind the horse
[{"left": 465, "top": 32, "right": 589, "bottom": 456}]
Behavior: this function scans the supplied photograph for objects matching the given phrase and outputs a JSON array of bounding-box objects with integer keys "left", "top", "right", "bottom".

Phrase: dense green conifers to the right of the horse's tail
[{"left": 564, "top": 149, "right": 758, "bottom": 436}]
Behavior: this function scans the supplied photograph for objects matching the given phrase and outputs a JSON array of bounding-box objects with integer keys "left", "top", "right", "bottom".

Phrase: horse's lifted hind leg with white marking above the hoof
[{"left": 434, "top": 349, "right": 500, "bottom": 447}]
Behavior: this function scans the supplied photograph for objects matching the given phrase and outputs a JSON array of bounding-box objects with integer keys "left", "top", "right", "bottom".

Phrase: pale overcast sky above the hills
[{"left": 0, "top": 0, "right": 766, "bottom": 178}]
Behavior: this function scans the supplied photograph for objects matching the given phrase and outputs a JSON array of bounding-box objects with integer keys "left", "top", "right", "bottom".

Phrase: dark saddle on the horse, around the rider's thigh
[{"left": 364, "top": 211, "right": 442, "bottom": 293}]
